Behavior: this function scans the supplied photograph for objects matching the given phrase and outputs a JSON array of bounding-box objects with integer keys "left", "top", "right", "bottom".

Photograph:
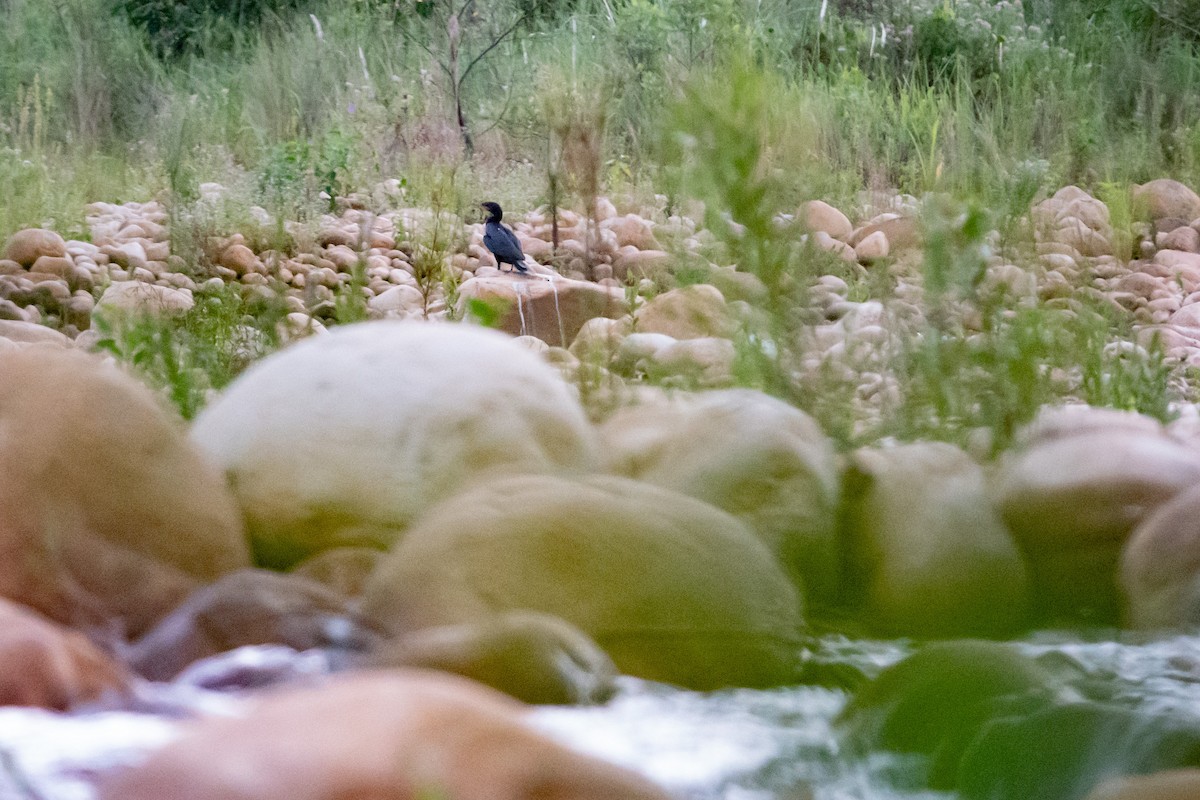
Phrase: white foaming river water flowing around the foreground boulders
[{"left": 7, "top": 636, "right": 1200, "bottom": 800}]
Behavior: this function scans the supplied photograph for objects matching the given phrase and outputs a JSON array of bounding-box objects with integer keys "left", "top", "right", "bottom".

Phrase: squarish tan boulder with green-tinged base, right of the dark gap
[{"left": 842, "top": 441, "right": 1030, "bottom": 637}]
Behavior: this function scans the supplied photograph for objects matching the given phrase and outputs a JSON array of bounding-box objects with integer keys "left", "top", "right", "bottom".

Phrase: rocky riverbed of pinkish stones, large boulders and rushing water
[{"left": 0, "top": 181, "right": 1200, "bottom": 800}]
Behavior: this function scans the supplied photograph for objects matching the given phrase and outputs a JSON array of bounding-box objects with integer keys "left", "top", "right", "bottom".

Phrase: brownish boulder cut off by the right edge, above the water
[{"left": 1121, "top": 487, "right": 1200, "bottom": 628}]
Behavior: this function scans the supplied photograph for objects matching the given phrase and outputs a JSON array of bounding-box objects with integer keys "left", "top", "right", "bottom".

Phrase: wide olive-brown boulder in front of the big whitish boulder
[{"left": 362, "top": 476, "right": 800, "bottom": 688}]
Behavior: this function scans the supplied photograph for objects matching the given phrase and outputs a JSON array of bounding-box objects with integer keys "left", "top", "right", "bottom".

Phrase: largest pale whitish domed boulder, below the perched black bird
[{"left": 192, "top": 321, "right": 596, "bottom": 566}]
